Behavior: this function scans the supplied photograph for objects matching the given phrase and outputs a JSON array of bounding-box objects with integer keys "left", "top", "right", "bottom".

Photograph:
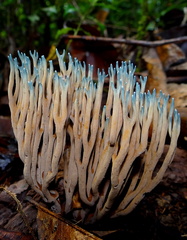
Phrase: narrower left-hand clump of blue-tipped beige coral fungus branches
[{"left": 8, "top": 52, "right": 72, "bottom": 210}]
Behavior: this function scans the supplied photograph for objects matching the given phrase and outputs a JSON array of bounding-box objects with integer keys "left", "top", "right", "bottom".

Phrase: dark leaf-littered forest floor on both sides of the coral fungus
[{"left": 0, "top": 24, "right": 187, "bottom": 240}]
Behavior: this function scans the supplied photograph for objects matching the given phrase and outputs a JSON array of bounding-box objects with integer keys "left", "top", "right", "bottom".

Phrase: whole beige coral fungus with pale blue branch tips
[{"left": 8, "top": 51, "right": 180, "bottom": 222}]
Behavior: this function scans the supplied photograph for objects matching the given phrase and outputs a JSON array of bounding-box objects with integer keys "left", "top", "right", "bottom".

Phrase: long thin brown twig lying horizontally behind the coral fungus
[{"left": 62, "top": 35, "right": 187, "bottom": 47}]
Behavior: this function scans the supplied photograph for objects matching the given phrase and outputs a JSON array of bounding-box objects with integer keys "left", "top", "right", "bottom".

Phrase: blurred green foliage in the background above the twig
[{"left": 0, "top": 0, "right": 186, "bottom": 55}]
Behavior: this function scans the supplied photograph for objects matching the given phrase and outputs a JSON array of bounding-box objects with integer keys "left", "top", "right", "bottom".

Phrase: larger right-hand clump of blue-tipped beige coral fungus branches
[{"left": 61, "top": 61, "right": 180, "bottom": 222}]
